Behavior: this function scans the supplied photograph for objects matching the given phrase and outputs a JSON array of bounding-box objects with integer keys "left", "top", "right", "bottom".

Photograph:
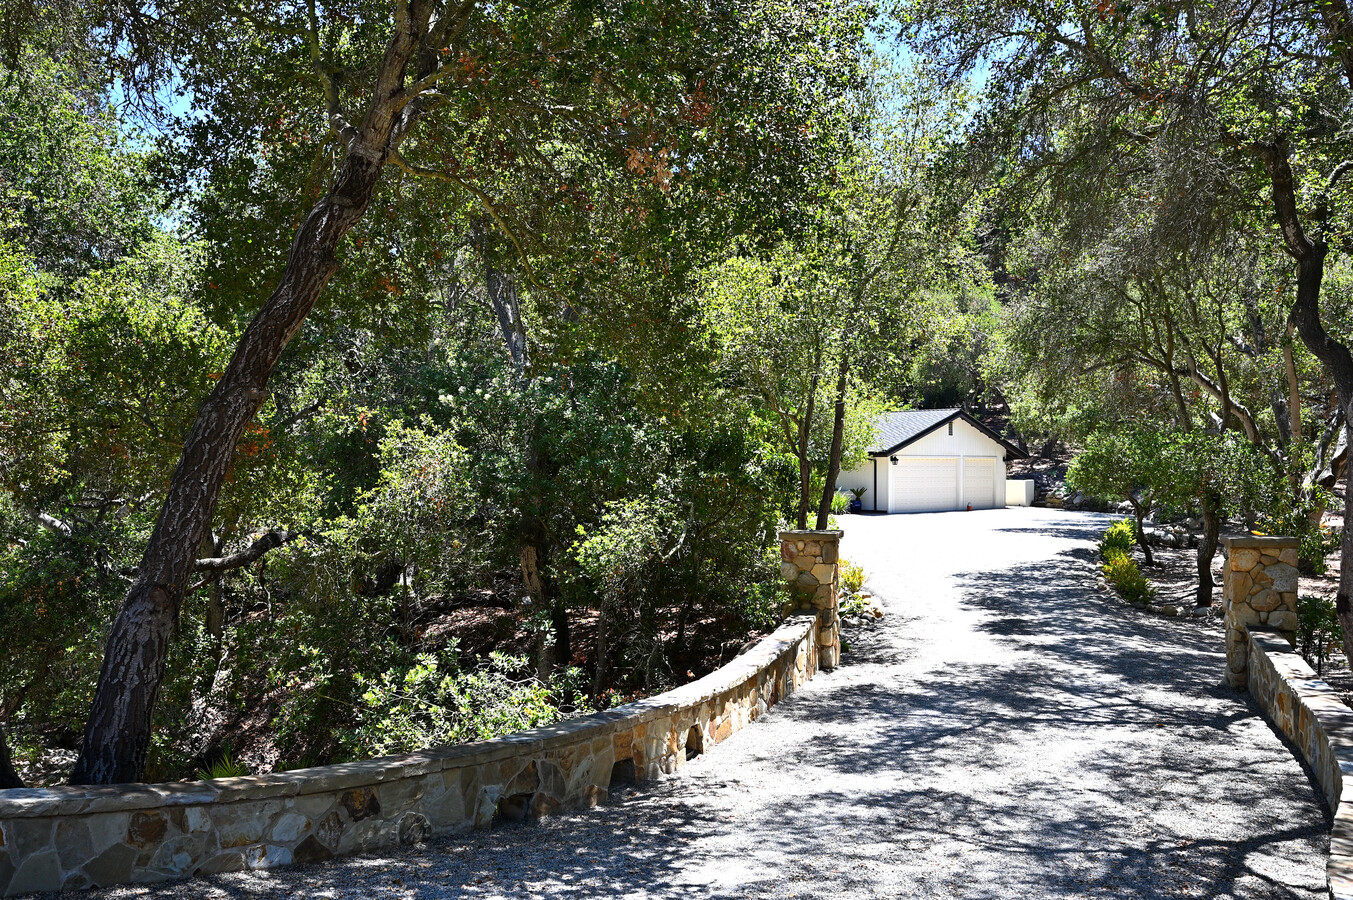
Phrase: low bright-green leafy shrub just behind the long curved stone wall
[{"left": 348, "top": 644, "right": 579, "bottom": 758}]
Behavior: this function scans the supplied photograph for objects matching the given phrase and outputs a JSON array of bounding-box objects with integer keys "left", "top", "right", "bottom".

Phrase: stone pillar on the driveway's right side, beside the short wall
[{"left": 1222, "top": 536, "right": 1300, "bottom": 688}]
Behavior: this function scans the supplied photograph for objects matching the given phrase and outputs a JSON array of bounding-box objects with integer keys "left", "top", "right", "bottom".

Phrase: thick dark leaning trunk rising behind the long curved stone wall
[{"left": 70, "top": 22, "right": 426, "bottom": 784}]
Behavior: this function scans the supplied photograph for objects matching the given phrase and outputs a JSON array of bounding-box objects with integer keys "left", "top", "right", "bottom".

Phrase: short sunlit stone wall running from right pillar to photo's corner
[{"left": 1247, "top": 625, "right": 1353, "bottom": 900}]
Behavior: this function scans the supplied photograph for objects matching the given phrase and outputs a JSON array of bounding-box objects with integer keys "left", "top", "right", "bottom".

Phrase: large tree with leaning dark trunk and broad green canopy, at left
[{"left": 0, "top": 0, "right": 865, "bottom": 782}]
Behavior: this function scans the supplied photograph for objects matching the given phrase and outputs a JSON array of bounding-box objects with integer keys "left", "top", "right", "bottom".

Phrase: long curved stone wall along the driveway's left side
[{"left": 0, "top": 611, "right": 835, "bottom": 897}]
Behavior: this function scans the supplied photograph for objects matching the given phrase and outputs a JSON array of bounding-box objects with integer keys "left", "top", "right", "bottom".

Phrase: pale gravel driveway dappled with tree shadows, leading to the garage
[{"left": 74, "top": 509, "right": 1329, "bottom": 900}]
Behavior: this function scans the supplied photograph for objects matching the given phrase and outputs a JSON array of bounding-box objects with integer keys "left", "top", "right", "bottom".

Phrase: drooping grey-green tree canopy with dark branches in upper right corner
[{"left": 898, "top": 0, "right": 1353, "bottom": 647}]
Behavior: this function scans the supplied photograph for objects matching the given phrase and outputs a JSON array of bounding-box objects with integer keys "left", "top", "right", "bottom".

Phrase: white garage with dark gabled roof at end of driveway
[{"left": 836, "top": 409, "right": 1024, "bottom": 513}]
